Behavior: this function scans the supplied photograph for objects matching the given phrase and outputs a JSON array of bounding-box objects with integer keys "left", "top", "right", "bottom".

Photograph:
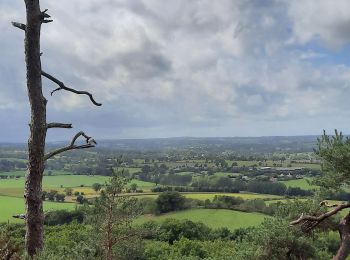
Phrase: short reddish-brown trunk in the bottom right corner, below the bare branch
[{"left": 333, "top": 213, "right": 350, "bottom": 260}]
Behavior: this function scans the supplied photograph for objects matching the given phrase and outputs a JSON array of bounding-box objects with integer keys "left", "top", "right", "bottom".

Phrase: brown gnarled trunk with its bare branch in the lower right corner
[{"left": 290, "top": 201, "right": 350, "bottom": 260}]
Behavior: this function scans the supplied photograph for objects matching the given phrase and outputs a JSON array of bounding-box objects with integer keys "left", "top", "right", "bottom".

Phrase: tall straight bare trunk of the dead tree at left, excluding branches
[{"left": 24, "top": 0, "right": 47, "bottom": 257}]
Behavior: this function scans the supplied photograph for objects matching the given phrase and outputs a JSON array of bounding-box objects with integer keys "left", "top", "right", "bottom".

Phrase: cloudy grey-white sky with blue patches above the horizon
[{"left": 0, "top": 0, "right": 350, "bottom": 142}]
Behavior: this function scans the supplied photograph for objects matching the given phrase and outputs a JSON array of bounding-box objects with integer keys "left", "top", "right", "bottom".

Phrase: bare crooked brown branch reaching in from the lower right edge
[{"left": 290, "top": 202, "right": 350, "bottom": 233}]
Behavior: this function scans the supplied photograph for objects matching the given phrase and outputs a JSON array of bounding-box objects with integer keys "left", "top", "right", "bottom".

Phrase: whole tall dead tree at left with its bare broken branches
[{"left": 12, "top": 0, "right": 101, "bottom": 257}]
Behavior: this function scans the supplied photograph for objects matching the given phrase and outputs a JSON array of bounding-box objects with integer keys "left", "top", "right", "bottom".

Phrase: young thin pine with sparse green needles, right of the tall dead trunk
[{"left": 90, "top": 173, "right": 142, "bottom": 259}]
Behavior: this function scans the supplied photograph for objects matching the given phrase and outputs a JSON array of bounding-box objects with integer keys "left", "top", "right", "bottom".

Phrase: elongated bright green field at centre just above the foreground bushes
[{"left": 136, "top": 209, "right": 266, "bottom": 230}]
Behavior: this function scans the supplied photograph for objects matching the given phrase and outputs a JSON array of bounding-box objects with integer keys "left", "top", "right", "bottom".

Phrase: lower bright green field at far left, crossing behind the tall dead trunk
[{"left": 0, "top": 196, "right": 75, "bottom": 223}]
